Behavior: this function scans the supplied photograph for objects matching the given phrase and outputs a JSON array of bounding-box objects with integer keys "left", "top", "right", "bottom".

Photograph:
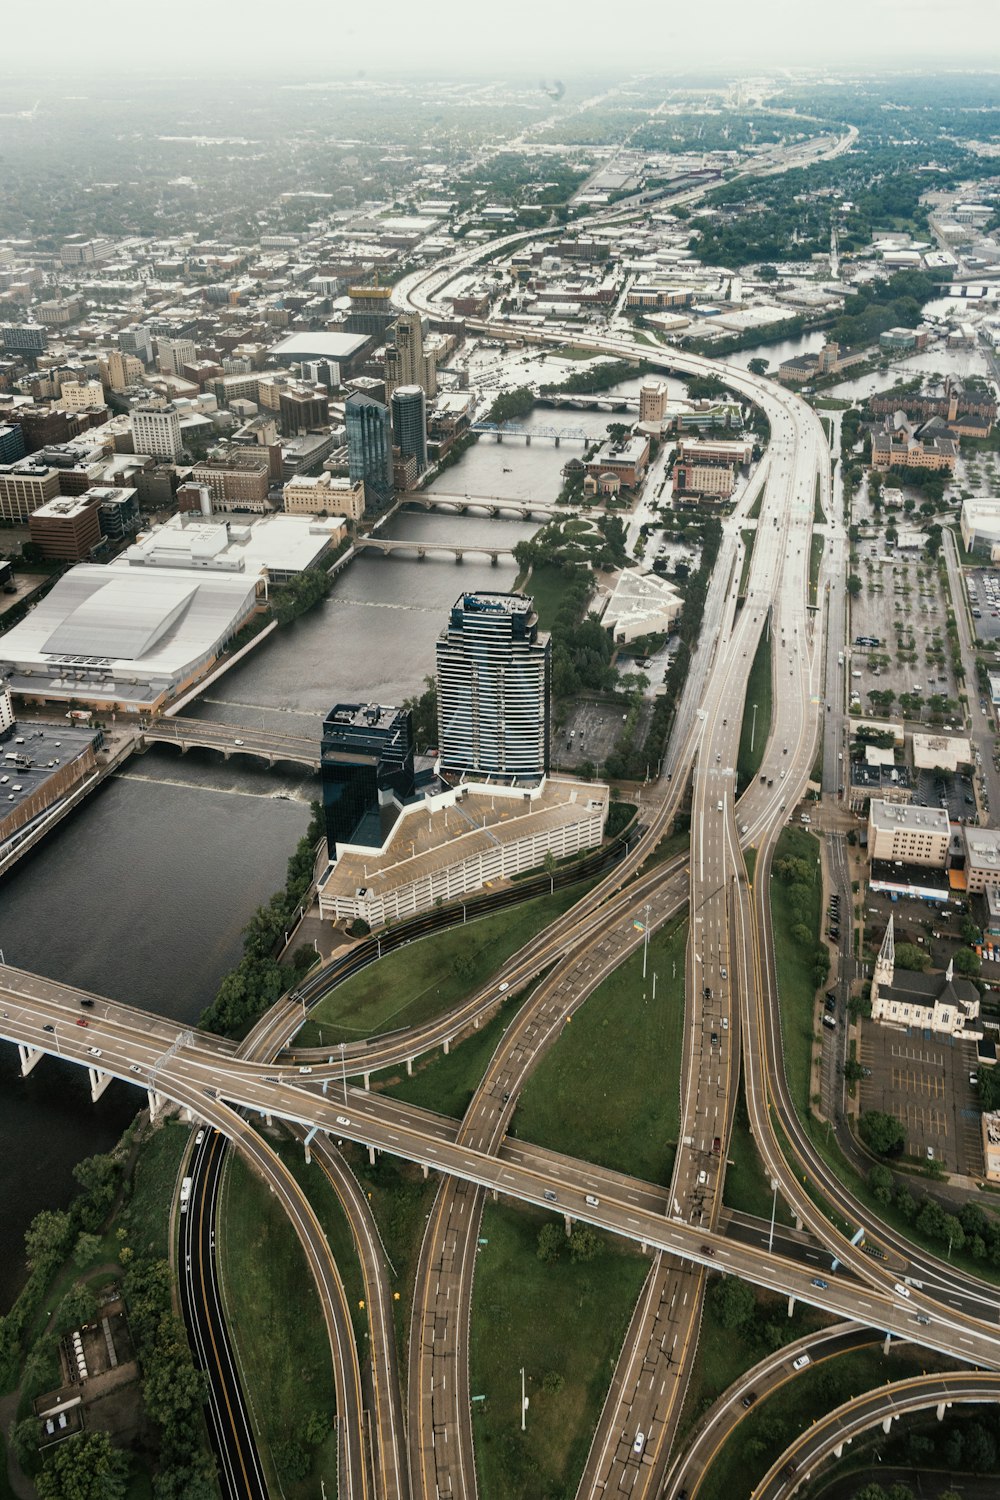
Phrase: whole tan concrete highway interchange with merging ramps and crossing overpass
[{"left": 0, "top": 129, "right": 1000, "bottom": 1497}]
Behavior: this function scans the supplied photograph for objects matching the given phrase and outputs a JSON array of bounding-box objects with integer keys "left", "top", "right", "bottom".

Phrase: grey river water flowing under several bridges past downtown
[{"left": 0, "top": 498, "right": 563, "bottom": 1310}]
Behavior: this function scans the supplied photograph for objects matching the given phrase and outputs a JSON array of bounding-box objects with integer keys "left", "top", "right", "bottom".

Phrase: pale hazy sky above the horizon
[{"left": 0, "top": 0, "right": 1000, "bottom": 74}]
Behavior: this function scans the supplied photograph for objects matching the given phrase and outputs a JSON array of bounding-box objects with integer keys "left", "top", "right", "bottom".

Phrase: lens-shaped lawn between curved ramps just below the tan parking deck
[{"left": 302, "top": 884, "right": 586, "bottom": 1047}]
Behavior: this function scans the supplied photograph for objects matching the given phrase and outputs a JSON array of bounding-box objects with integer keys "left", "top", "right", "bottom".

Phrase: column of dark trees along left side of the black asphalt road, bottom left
[{"left": 121, "top": 1248, "right": 216, "bottom": 1500}]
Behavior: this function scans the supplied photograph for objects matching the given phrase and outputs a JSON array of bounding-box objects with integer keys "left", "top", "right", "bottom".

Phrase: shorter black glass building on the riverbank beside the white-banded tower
[{"left": 319, "top": 704, "right": 414, "bottom": 860}]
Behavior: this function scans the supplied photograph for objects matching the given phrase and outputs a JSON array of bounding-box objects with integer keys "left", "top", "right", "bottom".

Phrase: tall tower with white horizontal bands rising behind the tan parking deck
[{"left": 438, "top": 593, "right": 552, "bottom": 780}]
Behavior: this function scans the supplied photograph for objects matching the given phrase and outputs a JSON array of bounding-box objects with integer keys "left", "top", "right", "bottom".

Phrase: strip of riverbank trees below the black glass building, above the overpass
[{"left": 198, "top": 803, "right": 324, "bottom": 1035}]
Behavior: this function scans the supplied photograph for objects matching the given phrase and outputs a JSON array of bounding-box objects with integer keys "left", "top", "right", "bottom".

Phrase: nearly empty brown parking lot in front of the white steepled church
[{"left": 859, "top": 1022, "right": 982, "bottom": 1178}]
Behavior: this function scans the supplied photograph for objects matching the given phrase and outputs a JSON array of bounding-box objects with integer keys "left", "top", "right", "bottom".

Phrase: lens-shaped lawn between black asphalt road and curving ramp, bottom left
[{"left": 217, "top": 1154, "right": 337, "bottom": 1500}]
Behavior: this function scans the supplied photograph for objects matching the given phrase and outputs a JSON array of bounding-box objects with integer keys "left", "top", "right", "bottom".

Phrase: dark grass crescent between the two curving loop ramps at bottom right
[{"left": 699, "top": 1335, "right": 942, "bottom": 1500}]
